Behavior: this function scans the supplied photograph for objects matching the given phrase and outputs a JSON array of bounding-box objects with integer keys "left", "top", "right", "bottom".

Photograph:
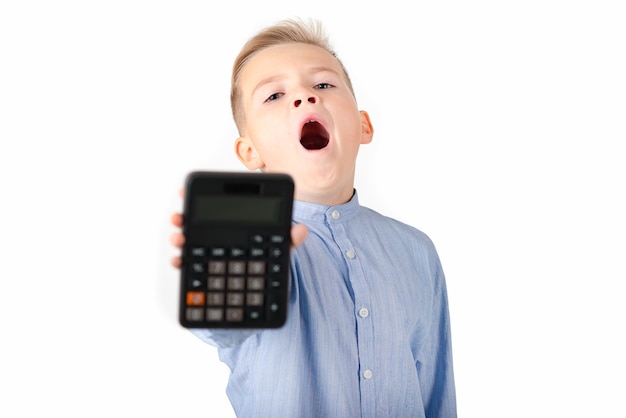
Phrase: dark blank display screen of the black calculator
[{"left": 191, "top": 196, "right": 283, "bottom": 224}]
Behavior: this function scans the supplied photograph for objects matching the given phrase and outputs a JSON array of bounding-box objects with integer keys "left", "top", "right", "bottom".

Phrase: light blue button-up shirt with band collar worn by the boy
[{"left": 193, "top": 192, "right": 456, "bottom": 418}]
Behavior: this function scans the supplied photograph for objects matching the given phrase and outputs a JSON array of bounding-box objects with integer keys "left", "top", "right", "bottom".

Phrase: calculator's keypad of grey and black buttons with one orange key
[{"left": 184, "top": 234, "right": 289, "bottom": 328}]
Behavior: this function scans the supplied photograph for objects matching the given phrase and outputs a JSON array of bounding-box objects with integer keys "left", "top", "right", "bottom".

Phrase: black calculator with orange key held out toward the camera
[{"left": 179, "top": 171, "right": 294, "bottom": 328}]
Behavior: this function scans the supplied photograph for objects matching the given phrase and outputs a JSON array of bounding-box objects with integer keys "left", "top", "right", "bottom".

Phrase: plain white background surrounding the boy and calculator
[{"left": 0, "top": 0, "right": 626, "bottom": 418}]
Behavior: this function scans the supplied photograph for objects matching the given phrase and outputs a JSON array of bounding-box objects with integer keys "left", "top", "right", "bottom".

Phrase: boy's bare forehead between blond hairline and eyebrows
[{"left": 240, "top": 43, "right": 343, "bottom": 93}]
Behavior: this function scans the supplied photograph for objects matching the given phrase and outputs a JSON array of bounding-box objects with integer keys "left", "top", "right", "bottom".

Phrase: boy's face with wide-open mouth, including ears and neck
[{"left": 235, "top": 43, "right": 373, "bottom": 205}]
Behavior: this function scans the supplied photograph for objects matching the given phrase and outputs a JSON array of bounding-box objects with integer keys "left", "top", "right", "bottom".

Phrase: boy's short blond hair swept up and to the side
[{"left": 230, "top": 19, "right": 354, "bottom": 133}]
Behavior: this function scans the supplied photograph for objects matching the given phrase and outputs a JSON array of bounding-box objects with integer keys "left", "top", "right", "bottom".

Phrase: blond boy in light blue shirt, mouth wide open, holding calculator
[{"left": 172, "top": 21, "right": 456, "bottom": 418}]
